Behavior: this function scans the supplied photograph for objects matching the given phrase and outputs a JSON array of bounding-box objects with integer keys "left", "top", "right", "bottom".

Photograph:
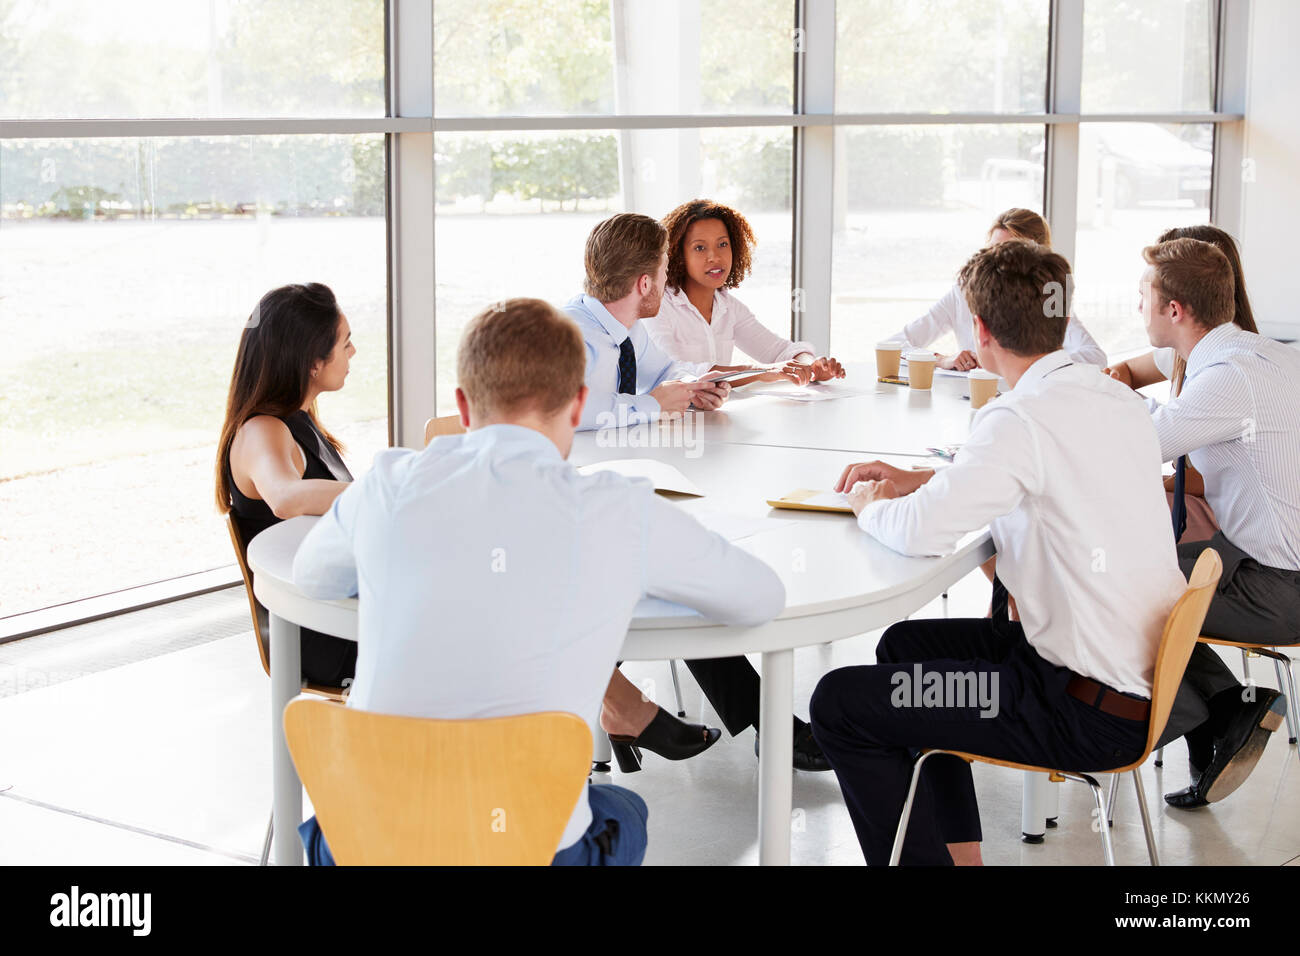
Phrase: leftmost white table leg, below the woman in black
[{"left": 270, "top": 614, "right": 303, "bottom": 866}]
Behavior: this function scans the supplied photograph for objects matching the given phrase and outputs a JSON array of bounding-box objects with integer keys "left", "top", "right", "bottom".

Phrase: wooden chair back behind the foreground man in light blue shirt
[{"left": 285, "top": 700, "right": 592, "bottom": 866}]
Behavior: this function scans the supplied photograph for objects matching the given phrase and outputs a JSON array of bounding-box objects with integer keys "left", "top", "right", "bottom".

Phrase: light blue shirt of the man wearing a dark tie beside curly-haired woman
[{"left": 564, "top": 295, "right": 715, "bottom": 431}]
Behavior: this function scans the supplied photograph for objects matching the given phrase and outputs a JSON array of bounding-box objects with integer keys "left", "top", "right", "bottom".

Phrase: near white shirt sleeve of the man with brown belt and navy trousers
[{"left": 858, "top": 406, "right": 1041, "bottom": 555}]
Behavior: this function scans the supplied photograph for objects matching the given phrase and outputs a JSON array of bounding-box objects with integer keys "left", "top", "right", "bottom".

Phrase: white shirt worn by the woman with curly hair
[{"left": 645, "top": 289, "right": 816, "bottom": 365}]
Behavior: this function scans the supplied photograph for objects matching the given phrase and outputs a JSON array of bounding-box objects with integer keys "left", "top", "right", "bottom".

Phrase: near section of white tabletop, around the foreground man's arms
[{"left": 248, "top": 434, "right": 992, "bottom": 659}]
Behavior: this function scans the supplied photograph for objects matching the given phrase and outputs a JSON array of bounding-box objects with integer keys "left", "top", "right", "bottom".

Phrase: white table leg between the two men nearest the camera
[{"left": 758, "top": 650, "right": 794, "bottom": 866}]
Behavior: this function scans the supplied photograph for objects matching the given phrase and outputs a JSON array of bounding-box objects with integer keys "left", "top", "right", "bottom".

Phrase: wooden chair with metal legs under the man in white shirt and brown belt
[{"left": 889, "top": 548, "right": 1223, "bottom": 866}]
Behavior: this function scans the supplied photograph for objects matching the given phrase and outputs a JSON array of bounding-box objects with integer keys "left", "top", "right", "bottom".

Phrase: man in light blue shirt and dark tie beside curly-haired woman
[{"left": 564, "top": 213, "right": 731, "bottom": 429}]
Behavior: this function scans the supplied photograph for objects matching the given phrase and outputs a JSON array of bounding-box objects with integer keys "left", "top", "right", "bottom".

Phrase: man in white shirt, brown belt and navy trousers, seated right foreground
[{"left": 811, "top": 241, "right": 1186, "bottom": 865}]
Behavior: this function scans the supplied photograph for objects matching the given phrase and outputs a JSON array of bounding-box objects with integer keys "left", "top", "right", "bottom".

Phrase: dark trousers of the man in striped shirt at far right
[{"left": 1161, "top": 532, "right": 1300, "bottom": 770}]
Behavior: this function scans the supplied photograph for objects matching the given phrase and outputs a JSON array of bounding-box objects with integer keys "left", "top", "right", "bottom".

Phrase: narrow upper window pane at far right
[{"left": 1082, "top": 0, "right": 1217, "bottom": 113}]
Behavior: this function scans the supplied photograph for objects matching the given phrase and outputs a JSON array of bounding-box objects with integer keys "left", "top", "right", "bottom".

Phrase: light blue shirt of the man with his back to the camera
[{"left": 294, "top": 425, "right": 785, "bottom": 848}]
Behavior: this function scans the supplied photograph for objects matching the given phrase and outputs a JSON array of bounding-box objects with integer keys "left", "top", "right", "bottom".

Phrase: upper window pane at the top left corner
[{"left": 0, "top": 0, "right": 385, "bottom": 120}]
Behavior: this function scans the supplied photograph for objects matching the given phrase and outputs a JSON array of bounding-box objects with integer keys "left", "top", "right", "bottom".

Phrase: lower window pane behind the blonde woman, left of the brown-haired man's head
[{"left": 831, "top": 125, "right": 1044, "bottom": 362}]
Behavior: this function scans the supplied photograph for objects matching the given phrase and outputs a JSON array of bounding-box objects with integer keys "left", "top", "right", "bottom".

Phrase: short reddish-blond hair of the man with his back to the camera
[{"left": 456, "top": 299, "right": 586, "bottom": 416}]
